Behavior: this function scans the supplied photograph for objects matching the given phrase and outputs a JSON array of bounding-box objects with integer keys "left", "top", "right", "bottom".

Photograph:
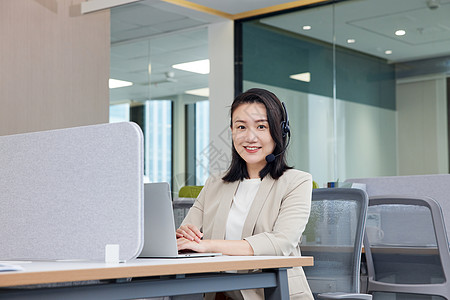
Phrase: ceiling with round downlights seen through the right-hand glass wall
[{"left": 261, "top": 0, "right": 450, "bottom": 62}]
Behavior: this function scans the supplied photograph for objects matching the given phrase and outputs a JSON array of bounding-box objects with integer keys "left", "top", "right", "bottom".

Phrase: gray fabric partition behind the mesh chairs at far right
[{"left": 346, "top": 174, "right": 450, "bottom": 243}]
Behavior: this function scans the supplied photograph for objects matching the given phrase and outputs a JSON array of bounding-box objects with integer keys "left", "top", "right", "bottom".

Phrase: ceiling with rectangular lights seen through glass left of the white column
[{"left": 110, "top": 1, "right": 210, "bottom": 103}]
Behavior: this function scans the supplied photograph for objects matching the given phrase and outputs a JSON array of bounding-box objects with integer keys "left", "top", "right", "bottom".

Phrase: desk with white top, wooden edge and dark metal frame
[{"left": 0, "top": 256, "right": 313, "bottom": 300}]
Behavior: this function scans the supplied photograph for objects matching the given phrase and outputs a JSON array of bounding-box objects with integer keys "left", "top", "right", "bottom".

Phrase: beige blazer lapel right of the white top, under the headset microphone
[{"left": 242, "top": 175, "right": 275, "bottom": 238}]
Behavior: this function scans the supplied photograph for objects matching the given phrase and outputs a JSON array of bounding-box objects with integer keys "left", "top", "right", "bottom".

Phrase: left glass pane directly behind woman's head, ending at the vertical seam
[{"left": 242, "top": 7, "right": 335, "bottom": 182}]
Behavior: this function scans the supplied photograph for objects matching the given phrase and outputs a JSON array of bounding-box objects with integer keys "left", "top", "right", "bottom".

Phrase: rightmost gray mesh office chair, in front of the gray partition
[{"left": 364, "top": 196, "right": 450, "bottom": 300}]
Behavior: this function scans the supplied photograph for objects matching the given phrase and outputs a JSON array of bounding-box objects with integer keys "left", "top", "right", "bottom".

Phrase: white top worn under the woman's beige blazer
[{"left": 225, "top": 178, "right": 261, "bottom": 240}]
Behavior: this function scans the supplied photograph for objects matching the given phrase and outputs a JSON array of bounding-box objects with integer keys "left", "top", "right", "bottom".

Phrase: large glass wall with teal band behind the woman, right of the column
[{"left": 240, "top": 0, "right": 450, "bottom": 186}]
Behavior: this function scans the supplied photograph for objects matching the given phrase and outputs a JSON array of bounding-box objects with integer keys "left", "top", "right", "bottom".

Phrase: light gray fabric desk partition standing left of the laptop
[{"left": 0, "top": 123, "right": 143, "bottom": 260}]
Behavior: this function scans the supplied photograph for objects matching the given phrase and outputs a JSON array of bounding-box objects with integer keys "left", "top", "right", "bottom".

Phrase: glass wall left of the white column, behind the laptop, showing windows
[{"left": 110, "top": 2, "right": 209, "bottom": 192}]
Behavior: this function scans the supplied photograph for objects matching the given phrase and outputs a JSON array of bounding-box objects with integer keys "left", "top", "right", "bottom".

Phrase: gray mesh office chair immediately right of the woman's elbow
[{"left": 300, "top": 188, "right": 372, "bottom": 300}]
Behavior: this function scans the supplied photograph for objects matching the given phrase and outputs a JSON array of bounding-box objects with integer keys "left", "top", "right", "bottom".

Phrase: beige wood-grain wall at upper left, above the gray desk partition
[{"left": 0, "top": 0, "right": 110, "bottom": 135}]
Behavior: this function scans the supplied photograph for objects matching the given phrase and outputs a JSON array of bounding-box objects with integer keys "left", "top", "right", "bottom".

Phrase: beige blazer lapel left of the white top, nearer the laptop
[{"left": 211, "top": 181, "right": 239, "bottom": 240}]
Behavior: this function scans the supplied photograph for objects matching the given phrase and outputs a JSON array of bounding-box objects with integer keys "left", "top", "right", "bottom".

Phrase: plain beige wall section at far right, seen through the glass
[{"left": 397, "top": 75, "right": 449, "bottom": 175}]
